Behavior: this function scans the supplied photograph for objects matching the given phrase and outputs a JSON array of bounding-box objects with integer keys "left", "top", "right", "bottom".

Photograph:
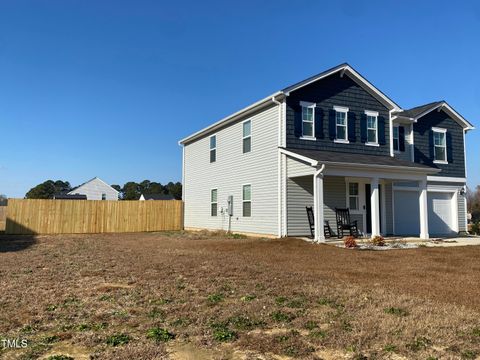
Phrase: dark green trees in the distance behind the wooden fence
[{"left": 25, "top": 180, "right": 182, "bottom": 200}]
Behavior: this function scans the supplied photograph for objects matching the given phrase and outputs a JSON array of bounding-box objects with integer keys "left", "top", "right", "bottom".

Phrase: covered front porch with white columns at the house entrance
[{"left": 286, "top": 148, "right": 440, "bottom": 241}]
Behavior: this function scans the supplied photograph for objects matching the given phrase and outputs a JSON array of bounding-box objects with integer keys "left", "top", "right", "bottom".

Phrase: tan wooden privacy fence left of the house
[{"left": 5, "top": 199, "right": 183, "bottom": 234}]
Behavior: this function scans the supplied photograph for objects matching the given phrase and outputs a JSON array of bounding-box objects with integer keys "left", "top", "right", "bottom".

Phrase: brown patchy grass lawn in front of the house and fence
[{"left": 0, "top": 233, "right": 480, "bottom": 359}]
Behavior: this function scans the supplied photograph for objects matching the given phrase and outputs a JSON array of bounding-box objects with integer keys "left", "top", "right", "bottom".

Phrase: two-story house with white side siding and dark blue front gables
[{"left": 180, "top": 64, "right": 473, "bottom": 240}]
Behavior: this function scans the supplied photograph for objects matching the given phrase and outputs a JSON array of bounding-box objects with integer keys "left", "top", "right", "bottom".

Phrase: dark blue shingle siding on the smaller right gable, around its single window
[{"left": 413, "top": 110, "right": 465, "bottom": 178}]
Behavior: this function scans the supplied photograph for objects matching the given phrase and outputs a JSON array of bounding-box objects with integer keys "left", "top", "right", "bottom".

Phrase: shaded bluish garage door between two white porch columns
[{"left": 393, "top": 190, "right": 420, "bottom": 236}]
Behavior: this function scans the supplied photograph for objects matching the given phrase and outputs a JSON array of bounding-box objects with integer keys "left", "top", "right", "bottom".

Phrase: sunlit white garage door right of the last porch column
[{"left": 428, "top": 191, "right": 453, "bottom": 235}]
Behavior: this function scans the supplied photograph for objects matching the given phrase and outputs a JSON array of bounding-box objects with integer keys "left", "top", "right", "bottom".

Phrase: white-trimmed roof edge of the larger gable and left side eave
[{"left": 178, "top": 63, "right": 402, "bottom": 145}]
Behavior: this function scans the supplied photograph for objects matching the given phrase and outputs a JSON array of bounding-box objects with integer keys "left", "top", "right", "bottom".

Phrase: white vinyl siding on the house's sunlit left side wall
[{"left": 184, "top": 106, "right": 278, "bottom": 235}]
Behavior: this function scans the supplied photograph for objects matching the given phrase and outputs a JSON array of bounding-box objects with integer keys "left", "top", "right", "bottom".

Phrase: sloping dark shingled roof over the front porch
[{"left": 285, "top": 148, "right": 440, "bottom": 174}]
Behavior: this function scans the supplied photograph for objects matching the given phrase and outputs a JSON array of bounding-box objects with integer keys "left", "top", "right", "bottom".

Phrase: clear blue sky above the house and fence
[{"left": 0, "top": 0, "right": 480, "bottom": 197}]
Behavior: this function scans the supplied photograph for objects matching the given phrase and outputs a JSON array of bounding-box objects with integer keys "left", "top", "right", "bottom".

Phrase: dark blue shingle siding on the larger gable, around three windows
[{"left": 286, "top": 73, "right": 390, "bottom": 156}]
